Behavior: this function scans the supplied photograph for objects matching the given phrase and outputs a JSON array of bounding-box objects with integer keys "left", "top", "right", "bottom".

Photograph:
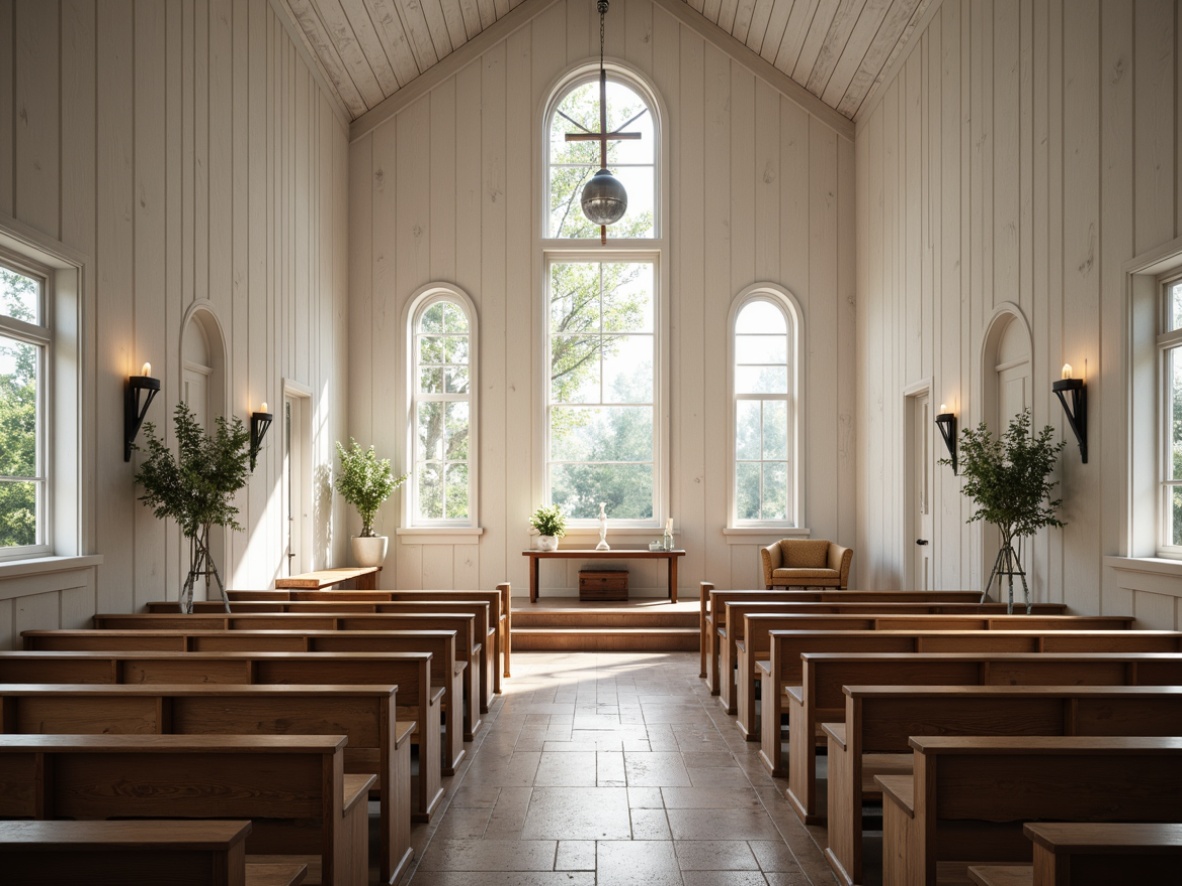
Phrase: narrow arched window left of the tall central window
[{"left": 407, "top": 286, "right": 478, "bottom": 527}]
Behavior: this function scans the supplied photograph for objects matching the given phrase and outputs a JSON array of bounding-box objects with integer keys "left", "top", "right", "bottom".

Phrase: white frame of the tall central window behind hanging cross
[{"left": 534, "top": 65, "right": 674, "bottom": 538}]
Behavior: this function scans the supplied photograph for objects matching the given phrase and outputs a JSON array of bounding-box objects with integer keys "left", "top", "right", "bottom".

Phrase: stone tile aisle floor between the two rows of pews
[{"left": 403, "top": 652, "right": 834, "bottom": 886}]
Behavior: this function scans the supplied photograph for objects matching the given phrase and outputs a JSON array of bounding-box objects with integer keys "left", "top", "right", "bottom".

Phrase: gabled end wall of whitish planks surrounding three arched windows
[{"left": 349, "top": 0, "right": 860, "bottom": 594}]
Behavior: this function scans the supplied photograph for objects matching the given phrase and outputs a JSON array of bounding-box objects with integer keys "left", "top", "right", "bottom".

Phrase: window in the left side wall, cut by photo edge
[{"left": 0, "top": 253, "right": 52, "bottom": 558}]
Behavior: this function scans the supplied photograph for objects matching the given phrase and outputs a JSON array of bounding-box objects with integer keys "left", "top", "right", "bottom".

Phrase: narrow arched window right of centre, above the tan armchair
[{"left": 729, "top": 285, "right": 800, "bottom": 527}]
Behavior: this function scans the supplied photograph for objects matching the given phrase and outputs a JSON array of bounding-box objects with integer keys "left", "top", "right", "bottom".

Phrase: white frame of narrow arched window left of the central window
[{"left": 400, "top": 284, "right": 480, "bottom": 534}]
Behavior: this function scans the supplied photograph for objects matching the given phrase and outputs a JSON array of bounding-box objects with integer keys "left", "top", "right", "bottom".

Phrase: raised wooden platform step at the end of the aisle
[{"left": 513, "top": 597, "right": 699, "bottom": 652}]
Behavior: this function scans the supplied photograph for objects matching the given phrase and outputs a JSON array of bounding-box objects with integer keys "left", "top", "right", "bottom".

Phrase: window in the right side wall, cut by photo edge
[{"left": 1157, "top": 274, "right": 1182, "bottom": 556}]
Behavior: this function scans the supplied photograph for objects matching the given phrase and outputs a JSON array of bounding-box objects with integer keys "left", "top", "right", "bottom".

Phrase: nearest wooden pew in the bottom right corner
[{"left": 968, "top": 821, "right": 1182, "bottom": 886}]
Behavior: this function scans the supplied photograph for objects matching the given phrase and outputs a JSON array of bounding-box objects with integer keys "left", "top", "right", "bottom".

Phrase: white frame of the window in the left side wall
[{"left": 0, "top": 249, "right": 53, "bottom": 560}]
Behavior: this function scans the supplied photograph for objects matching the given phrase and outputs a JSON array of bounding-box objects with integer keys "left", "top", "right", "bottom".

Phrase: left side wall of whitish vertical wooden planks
[{"left": 0, "top": 0, "right": 349, "bottom": 647}]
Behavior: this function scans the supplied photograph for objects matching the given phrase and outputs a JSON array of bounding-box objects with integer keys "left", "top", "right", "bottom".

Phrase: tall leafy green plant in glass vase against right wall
[{"left": 940, "top": 409, "right": 1066, "bottom": 613}]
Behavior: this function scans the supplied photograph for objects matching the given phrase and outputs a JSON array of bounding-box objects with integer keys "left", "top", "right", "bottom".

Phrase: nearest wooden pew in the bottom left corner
[{"left": 0, "top": 819, "right": 307, "bottom": 886}]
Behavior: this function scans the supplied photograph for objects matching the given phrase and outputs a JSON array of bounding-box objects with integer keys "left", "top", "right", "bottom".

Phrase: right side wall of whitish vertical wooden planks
[{"left": 856, "top": 0, "right": 1182, "bottom": 628}]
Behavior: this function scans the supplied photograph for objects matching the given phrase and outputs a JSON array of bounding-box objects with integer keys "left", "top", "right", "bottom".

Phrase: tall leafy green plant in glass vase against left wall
[{"left": 134, "top": 402, "right": 251, "bottom": 612}]
